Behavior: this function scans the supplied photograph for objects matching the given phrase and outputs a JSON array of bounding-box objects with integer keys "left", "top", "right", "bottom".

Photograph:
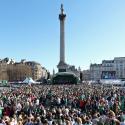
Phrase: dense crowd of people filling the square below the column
[{"left": 0, "top": 83, "right": 125, "bottom": 125}]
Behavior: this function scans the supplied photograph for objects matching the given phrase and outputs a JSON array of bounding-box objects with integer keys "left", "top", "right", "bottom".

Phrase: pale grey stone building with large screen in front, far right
[{"left": 90, "top": 57, "right": 125, "bottom": 80}]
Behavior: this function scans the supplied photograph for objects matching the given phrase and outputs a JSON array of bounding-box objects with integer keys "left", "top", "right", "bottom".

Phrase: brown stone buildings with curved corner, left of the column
[{"left": 0, "top": 58, "right": 48, "bottom": 81}]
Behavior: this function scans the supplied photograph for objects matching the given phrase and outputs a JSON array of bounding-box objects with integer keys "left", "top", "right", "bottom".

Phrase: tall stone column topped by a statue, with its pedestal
[{"left": 57, "top": 4, "right": 68, "bottom": 72}]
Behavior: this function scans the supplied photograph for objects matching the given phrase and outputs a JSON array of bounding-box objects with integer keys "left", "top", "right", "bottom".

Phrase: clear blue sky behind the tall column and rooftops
[{"left": 0, "top": 0, "right": 125, "bottom": 72}]
